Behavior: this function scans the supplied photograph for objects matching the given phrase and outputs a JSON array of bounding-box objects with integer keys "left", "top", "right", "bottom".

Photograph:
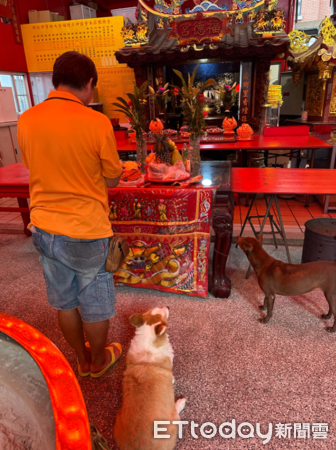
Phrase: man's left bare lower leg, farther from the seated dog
[{"left": 58, "top": 309, "right": 91, "bottom": 372}]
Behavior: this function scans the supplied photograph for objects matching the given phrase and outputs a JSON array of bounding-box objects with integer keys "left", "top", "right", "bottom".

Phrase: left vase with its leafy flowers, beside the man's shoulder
[{"left": 112, "top": 81, "right": 147, "bottom": 173}]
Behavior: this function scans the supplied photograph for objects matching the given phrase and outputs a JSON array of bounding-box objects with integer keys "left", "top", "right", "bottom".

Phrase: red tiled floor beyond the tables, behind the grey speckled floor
[{"left": 0, "top": 196, "right": 336, "bottom": 239}]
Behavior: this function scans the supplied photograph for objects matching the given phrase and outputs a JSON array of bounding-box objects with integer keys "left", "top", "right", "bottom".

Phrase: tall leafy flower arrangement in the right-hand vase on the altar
[{"left": 173, "top": 66, "right": 216, "bottom": 137}]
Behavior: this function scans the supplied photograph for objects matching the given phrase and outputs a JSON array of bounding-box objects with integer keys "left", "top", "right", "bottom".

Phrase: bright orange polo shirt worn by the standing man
[{"left": 18, "top": 91, "right": 121, "bottom": 239}]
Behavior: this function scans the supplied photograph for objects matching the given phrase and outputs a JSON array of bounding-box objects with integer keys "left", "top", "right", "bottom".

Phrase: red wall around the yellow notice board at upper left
[{"left": 0, "top": 0, "right": 111, "bottom": 72}]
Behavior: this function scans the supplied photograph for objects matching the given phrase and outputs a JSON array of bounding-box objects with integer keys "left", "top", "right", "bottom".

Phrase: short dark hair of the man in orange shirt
[{"left": 52, "top": 52, "right": 98, "bottom": 90}]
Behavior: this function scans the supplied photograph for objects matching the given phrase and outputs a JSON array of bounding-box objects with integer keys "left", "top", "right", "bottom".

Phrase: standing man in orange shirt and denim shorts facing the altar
[{"left": 18, "top": 52, "right": 122, "bottom": 378}]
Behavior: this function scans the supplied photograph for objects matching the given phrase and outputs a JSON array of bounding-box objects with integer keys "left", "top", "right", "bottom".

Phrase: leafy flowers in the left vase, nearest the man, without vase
[{"left": 112, "top": 81, "right": 147, "bottom": 140}]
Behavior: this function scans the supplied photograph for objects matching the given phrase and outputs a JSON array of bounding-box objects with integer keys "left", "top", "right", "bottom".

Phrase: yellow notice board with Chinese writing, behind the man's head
[{"left": 21, "top": 17, "right": 126, "bottom": 72}]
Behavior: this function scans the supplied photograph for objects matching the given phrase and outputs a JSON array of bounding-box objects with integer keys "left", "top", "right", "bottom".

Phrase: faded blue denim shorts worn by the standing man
[{"left": 32, "top": 227, "right": 116, "bottom": 322}]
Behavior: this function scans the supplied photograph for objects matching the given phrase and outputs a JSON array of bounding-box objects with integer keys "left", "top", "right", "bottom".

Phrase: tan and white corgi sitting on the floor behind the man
[{"left": 114, "top": 307, "right": 186, "bottom": 450}]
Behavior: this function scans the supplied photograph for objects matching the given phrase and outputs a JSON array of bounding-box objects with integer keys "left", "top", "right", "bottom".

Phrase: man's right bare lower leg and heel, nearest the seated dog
[{"left": 83, "top": 320, "right": 120, "bottom": 373}]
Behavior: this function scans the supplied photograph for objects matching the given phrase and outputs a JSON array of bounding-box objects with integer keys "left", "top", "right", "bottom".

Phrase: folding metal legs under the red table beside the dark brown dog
[{"left": 236, "top": 194, "right": 291, "bottom": 279}]
